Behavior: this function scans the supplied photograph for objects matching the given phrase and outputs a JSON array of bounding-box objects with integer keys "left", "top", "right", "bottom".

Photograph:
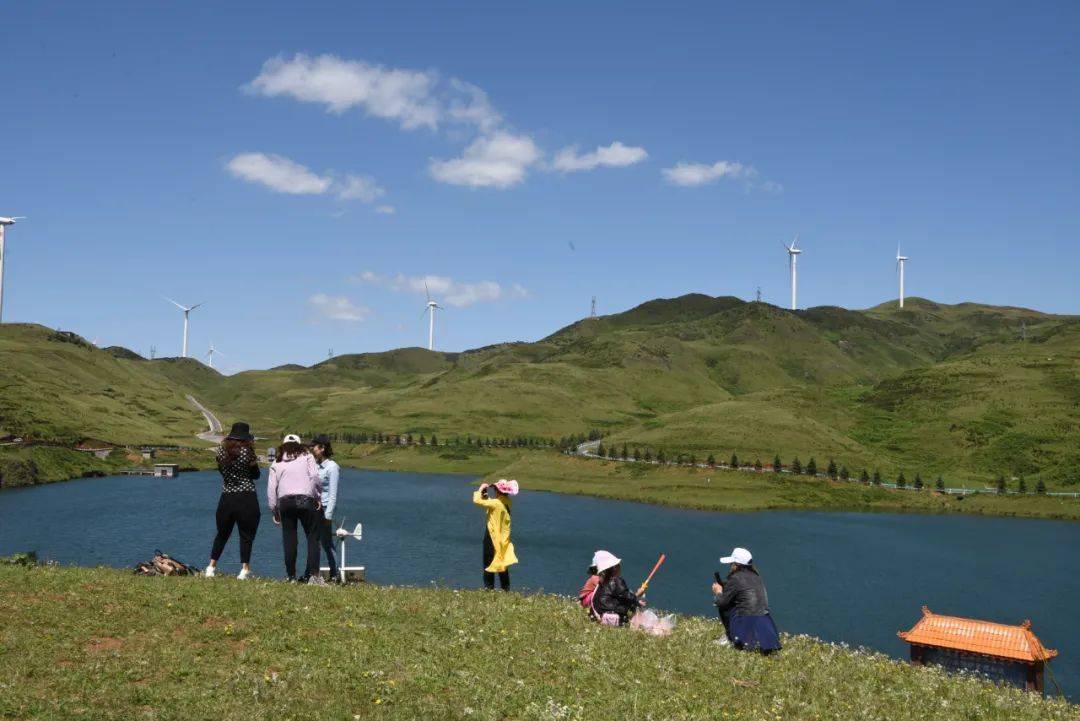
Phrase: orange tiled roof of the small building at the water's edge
[{"left": 896, "top": 606, "right": 1057, "bottom": 662}]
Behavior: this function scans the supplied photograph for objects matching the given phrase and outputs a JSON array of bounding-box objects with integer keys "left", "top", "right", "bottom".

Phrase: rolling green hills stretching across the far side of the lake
[{"left": 0, "top": 295, "right": 1080, "bottom": 486}]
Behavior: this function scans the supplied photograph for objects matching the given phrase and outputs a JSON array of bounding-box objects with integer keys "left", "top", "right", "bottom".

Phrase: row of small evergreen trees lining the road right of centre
[{"left": 583, "top": 443, "right": 1047, "bottom": 495}]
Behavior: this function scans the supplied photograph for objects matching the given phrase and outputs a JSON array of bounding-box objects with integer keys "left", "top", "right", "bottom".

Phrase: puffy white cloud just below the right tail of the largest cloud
[{"left": 428, "top": 132, "right": 541, "bottom": 189}]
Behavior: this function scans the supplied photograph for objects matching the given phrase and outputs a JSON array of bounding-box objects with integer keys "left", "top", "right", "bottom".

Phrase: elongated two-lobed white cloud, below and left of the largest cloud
[{"left": 226, "top": 152, "right": 387, "bottom": 203}]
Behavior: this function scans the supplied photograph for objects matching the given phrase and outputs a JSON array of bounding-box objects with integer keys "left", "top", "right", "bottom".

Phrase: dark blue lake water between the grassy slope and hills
[{"left": 0, "top": 470, "right": 1080, "bottom": 697}]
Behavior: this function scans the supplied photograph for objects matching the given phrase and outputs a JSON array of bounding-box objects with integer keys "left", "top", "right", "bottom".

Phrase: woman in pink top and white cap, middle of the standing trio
[{"left": 267, "top": 434, "right": 323, "bottom": 582}]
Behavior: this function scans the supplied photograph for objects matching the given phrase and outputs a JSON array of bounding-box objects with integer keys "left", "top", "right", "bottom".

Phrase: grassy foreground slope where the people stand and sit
[{"left": 0, "top": 564, "right": 1080, "bottom": 721}]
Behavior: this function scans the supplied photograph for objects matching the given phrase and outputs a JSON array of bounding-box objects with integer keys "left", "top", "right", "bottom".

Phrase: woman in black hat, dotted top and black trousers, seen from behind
[{"left": 206, "top": 422, "right": 261, "bottom": 580}]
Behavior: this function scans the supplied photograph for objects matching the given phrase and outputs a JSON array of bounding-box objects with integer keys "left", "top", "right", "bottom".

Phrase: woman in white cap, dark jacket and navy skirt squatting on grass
[{"left": 713, "top": 548, "right": 780, "bottom": 654}]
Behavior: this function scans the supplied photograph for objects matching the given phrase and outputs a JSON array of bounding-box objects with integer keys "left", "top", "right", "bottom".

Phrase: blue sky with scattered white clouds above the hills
[{"left": 0, "top": 2, "right": 1080, "bottom": 370}]
